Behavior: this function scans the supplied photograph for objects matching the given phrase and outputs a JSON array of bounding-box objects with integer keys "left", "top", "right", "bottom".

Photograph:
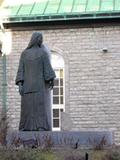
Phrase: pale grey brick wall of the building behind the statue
[{"left": 0, "top": 25, "right": 120, "bottom": 144}]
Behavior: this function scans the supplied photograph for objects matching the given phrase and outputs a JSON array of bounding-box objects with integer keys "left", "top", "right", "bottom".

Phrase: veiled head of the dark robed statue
[{"left": 27, "top": 32, "right": 43, "bottom": 49}]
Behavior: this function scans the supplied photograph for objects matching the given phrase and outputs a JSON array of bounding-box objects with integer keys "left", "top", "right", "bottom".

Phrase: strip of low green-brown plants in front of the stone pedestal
[{"left": 0, "top": 148, "right": 120, "bottom": 160}]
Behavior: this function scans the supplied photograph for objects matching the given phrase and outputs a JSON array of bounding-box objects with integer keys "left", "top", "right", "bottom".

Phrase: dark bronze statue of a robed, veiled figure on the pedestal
[{"left": 16, "top": 32, "right": 55, "bottom": 131}]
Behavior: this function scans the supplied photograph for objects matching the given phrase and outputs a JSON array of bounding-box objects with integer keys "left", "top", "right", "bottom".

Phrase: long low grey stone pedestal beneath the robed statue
[{"left": 7, "top": 131, "right": 113, "bottom": 148}]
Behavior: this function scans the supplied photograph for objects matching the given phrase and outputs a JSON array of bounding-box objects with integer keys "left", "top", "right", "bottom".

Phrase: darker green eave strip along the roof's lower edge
[{"left": 2, "top": 12, "right": 120, "bottom": 23}]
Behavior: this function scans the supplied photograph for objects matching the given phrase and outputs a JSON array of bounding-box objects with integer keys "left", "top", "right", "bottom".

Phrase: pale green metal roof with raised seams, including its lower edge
[{"left": 1, "top": 0, "right": 120, "bottom": 23}]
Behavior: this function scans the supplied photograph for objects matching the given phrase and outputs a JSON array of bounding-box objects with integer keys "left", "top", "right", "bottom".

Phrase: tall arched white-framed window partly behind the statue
[{"left": 52, "top": 54, "right": 65, "bottom": 131}]
